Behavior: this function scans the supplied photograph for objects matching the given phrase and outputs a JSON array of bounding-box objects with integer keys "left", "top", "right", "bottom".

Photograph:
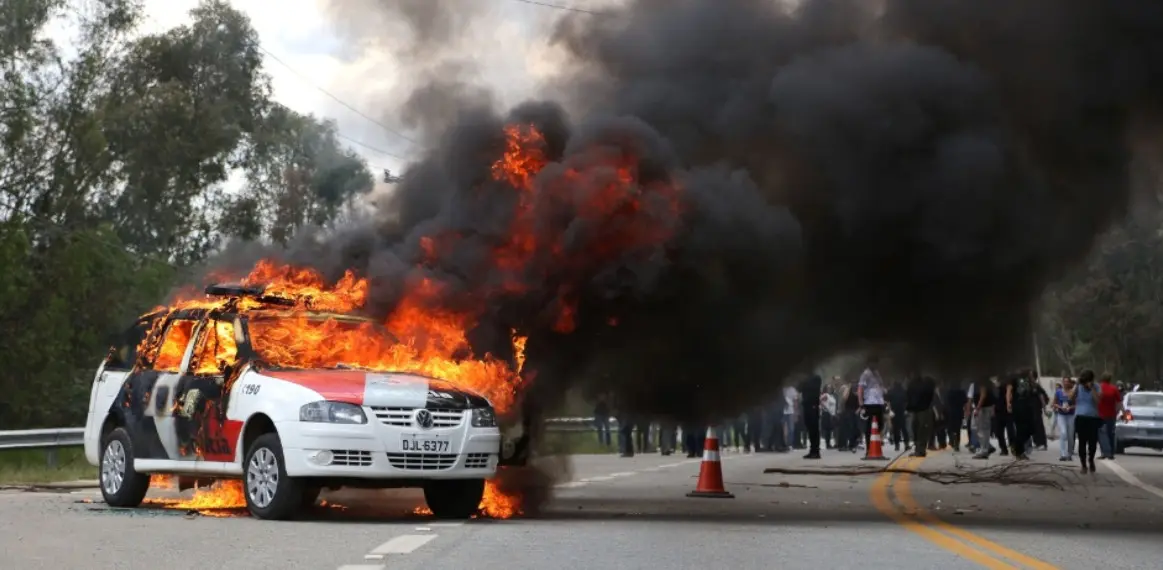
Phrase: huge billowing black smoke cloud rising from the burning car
[{"left": 209, "top": 0, "right": 1163, "bottom": 418}]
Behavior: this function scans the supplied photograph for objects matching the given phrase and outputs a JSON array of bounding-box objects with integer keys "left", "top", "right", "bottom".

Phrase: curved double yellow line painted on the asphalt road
[{"left": 870, "top": 457, "right": 1058, "bottom": 570}]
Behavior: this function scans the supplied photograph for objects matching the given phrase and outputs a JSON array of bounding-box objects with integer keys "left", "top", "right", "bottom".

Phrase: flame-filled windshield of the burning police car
[{"left": 247, "top": 313, "right": 399, "bottom": 370}]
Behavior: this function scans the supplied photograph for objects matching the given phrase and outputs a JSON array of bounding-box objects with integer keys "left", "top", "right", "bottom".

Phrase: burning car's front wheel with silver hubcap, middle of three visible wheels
[{"left": 242, "top": 433, "right": 305, "bottom": 520}]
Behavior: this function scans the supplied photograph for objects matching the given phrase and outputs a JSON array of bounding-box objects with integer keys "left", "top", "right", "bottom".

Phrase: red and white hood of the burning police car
[{"left": 262, "top": 370, "right": 488, "bottom": 409}]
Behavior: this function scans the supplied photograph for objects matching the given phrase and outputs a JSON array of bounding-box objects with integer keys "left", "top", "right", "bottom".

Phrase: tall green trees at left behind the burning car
[{"left": 0, "top": 0, "right": 374, "bottom": 429}]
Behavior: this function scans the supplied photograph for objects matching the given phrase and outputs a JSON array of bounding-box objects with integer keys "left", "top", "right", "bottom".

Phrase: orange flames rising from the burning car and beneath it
[{"left": 130, "top": 124, "right": 679, "bottom": 518}]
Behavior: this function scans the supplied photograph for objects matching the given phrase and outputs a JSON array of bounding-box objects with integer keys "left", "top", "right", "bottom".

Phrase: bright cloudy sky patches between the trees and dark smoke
[{"left": 133, "top": 0, "right": 590, "bottom": 173}]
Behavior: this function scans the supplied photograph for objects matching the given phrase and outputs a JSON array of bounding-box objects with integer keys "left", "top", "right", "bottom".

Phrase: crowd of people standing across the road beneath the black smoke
[{"left": 594, "top": 356, "right": 1125, "bottom": 473}]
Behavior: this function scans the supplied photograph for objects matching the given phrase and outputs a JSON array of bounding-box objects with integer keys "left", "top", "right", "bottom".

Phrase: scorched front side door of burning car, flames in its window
[{"left": 173, "top": 316, "right": 242, "bottom": 462}]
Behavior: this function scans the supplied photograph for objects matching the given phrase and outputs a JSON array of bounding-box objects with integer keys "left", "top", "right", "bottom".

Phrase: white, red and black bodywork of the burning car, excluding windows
[{"left": 84, "top": 311, "right": 501, "bottom": 518}]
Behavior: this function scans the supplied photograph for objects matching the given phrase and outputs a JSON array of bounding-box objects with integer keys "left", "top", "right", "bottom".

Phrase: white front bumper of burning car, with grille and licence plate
[{"left": 281, "top": 421, "right": 501, "bottom": 479}]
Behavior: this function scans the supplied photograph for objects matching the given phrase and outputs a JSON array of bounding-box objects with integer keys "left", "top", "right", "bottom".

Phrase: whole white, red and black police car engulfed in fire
[{"left": 85, "top": 286, "right": 512, "bottom": 519}]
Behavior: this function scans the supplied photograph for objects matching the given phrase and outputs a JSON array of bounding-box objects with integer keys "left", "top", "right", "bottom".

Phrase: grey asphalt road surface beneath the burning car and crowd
[{"left": 0, "top": 439, "right": 1163, "bottom": 570}]
